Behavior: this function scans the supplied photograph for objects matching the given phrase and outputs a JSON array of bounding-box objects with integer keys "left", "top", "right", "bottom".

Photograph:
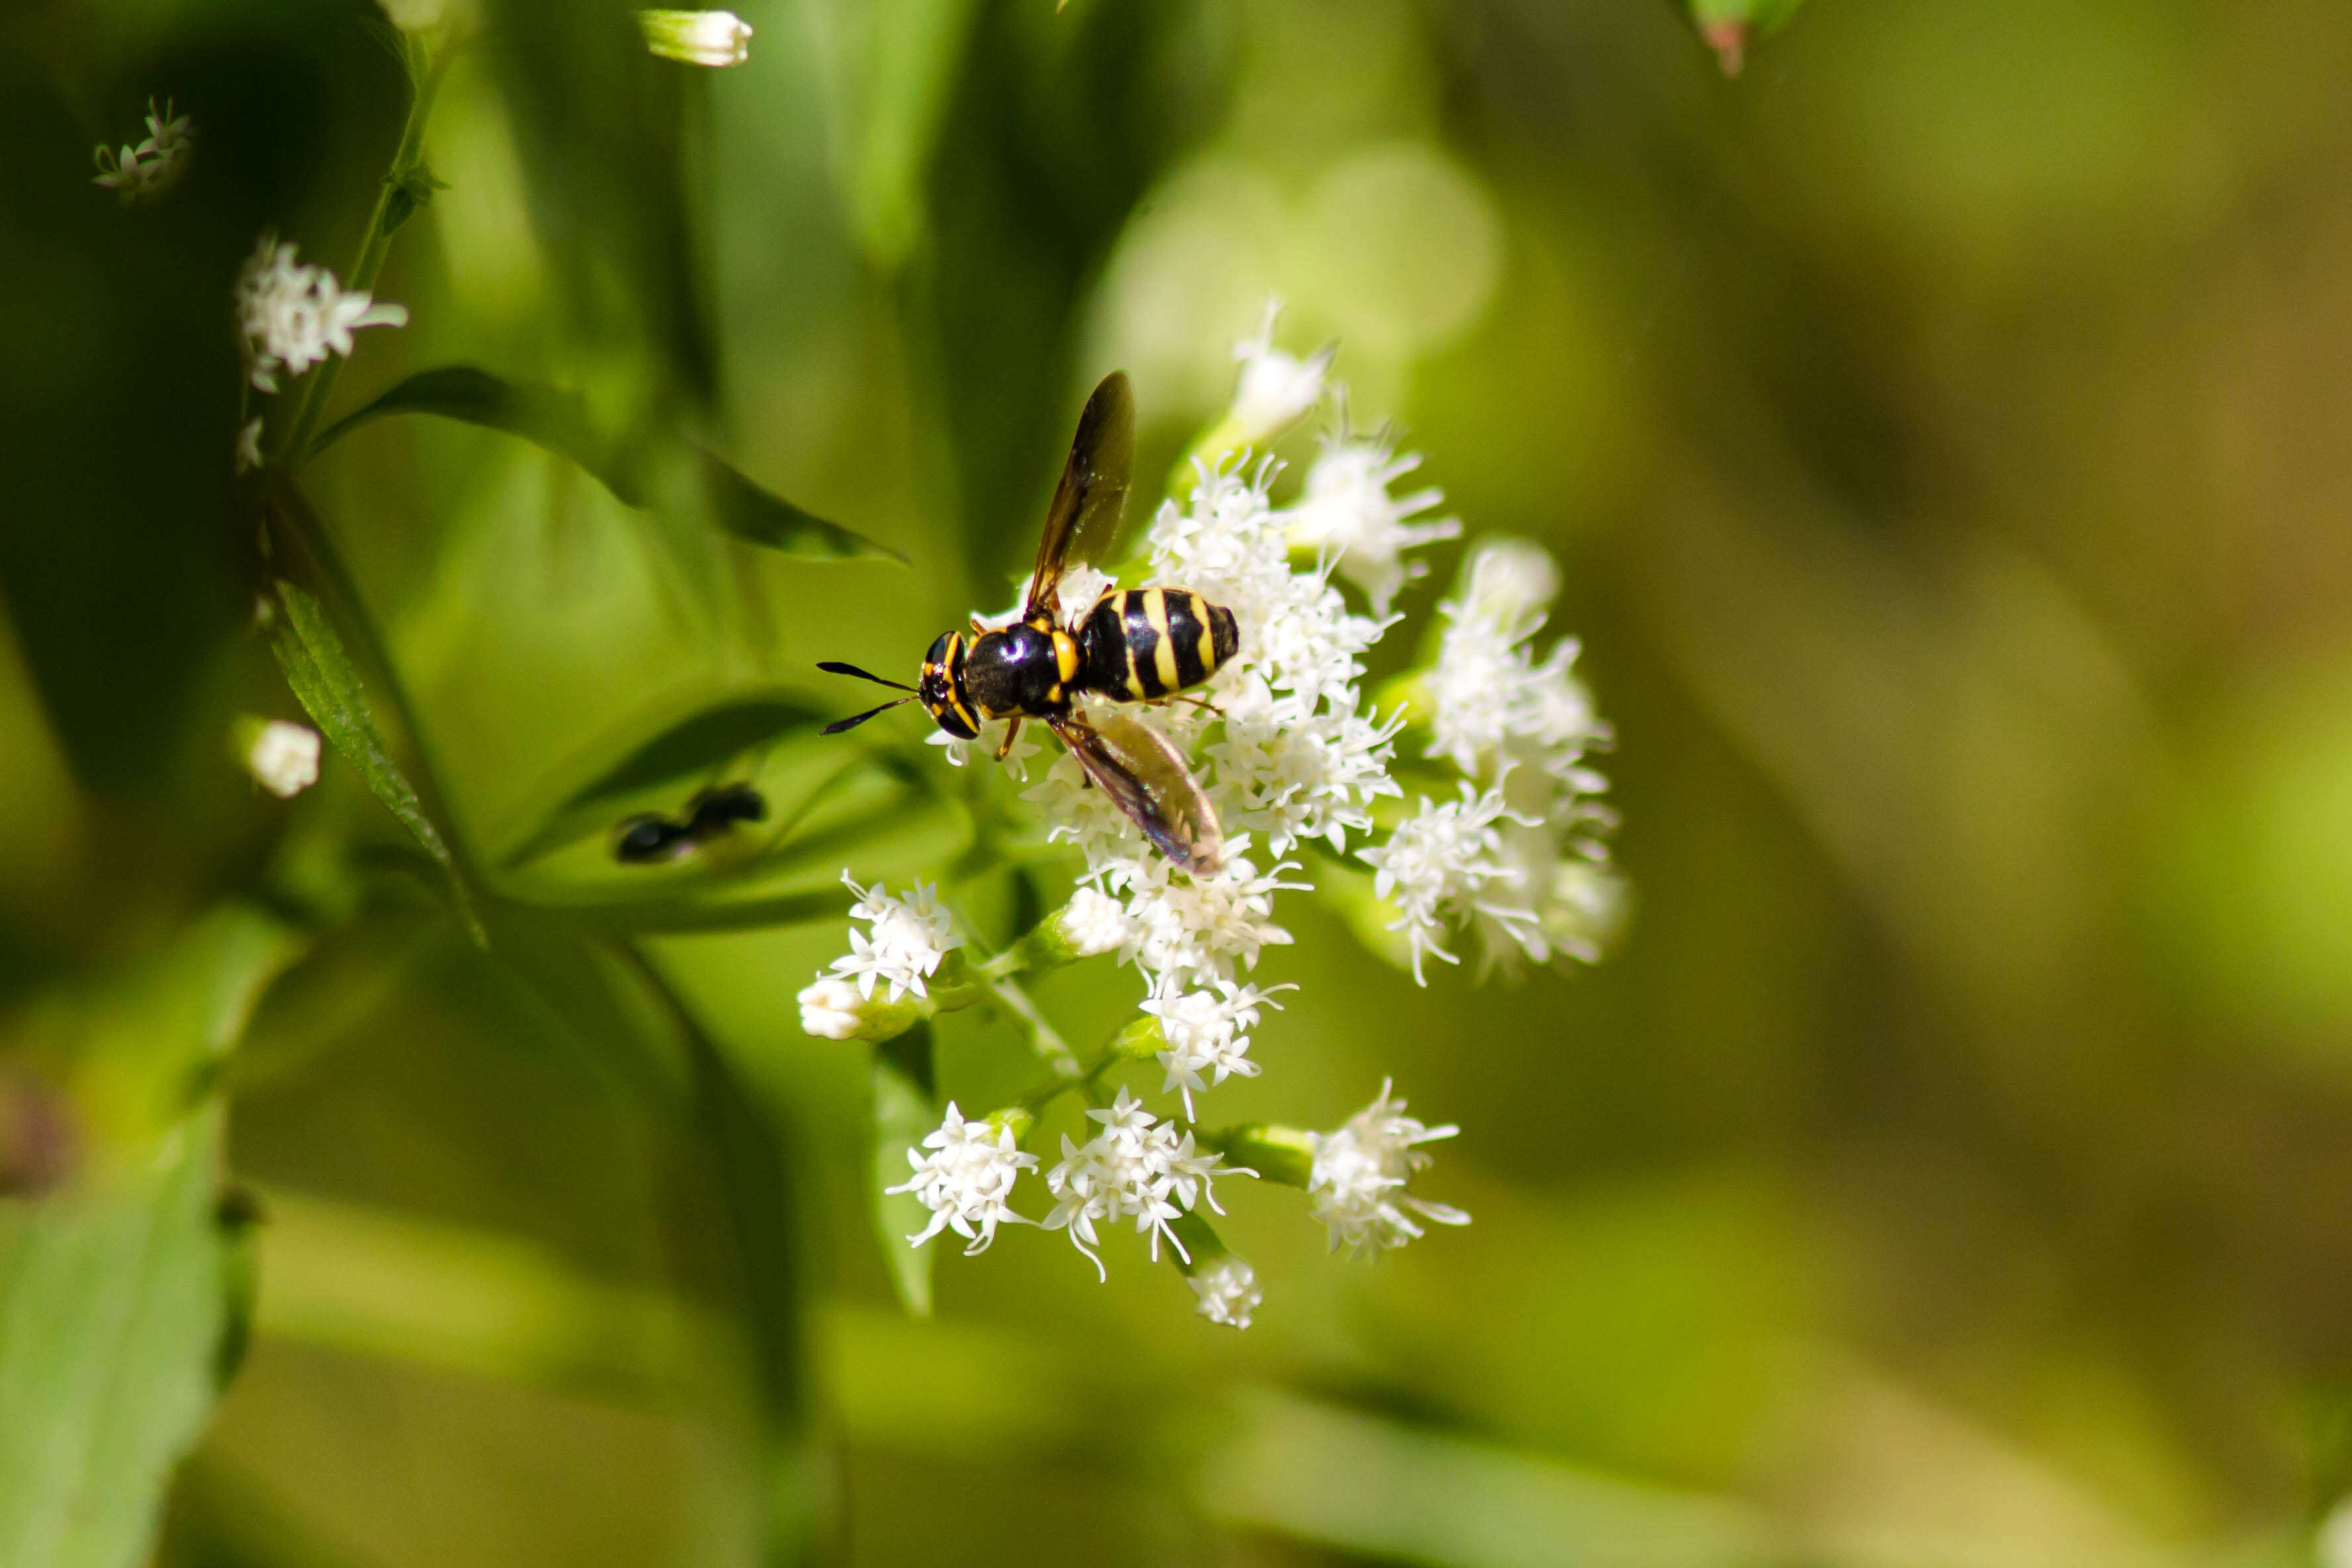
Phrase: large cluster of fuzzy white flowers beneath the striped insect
[{"left": 837, "top": 322, "right": 1616, "bottom": 1328}]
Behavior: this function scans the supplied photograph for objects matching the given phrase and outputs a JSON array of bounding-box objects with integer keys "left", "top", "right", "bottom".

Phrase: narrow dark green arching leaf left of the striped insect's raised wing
[{"left": 310, "top": 365, "right": 906, "bottom": 562}]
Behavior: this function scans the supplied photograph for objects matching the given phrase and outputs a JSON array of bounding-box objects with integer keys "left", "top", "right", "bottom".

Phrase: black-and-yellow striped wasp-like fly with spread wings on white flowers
[{"left": 818, "top": 371, "right": 1239, "bottom": 872}]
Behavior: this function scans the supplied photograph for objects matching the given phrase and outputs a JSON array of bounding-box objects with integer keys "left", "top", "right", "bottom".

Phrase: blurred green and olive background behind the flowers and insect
[{"left": 0, "top": 0, "right": 2352, "bottom": 1568}]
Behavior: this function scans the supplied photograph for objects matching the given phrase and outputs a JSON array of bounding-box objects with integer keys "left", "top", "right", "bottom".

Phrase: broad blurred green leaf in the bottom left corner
[{"left": 0, "top": 910, "right": 297, "bottom": 1568}]
